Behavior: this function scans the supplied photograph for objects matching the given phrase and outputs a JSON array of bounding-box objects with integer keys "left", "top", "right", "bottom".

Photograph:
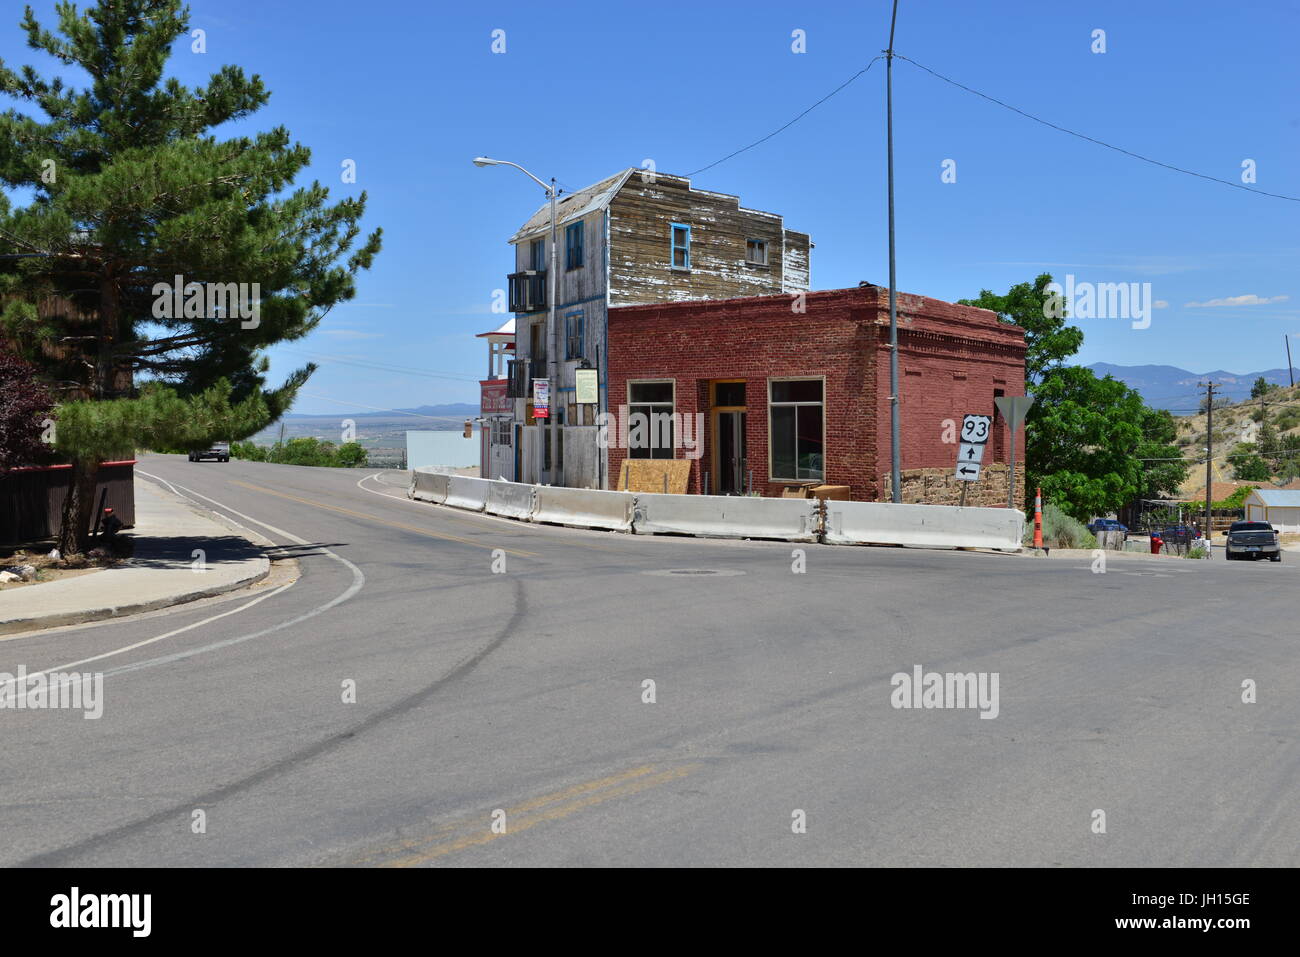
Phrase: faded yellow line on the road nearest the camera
[{"left": 366, "top": 763, "right": 701, "bottom": 867}]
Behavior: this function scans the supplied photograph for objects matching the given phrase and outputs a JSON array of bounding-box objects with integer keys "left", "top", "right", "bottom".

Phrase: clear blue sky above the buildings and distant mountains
[{"left": 0, "top": 0, "right": 1300, "bottom": 413}]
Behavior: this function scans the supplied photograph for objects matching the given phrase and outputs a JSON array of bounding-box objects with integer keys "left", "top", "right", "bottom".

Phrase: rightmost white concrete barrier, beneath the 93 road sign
[{"left": 824, "top": 502, "right": 1024, "bottom": 550}]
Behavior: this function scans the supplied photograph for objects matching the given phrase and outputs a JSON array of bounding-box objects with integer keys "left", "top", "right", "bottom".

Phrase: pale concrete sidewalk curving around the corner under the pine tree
[{"left": 0, "top": 477, "right": 270, "bottom": 635}]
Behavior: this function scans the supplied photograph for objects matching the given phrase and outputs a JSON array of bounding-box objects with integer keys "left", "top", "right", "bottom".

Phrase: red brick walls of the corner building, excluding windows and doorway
[{"left": 608, "top": 287, "right": 1024, "bottom": 503}]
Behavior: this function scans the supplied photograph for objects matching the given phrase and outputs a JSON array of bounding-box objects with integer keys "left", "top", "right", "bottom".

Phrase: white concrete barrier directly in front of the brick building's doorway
[{"left": 632, "top": 493, "right": 818, "bottom": 542}]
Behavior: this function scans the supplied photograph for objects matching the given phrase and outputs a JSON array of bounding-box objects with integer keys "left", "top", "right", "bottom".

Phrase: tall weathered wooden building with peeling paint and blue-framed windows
[{"left": 501, "top": 169, "right": 813, "bottom": 488}]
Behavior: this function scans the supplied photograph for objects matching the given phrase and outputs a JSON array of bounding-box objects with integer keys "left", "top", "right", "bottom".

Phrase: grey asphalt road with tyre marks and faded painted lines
[{"left": 0, "top": 456, "right": 1300, "bottom": 866}]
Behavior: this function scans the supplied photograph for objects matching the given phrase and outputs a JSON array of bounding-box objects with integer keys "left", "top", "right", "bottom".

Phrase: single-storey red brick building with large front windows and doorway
[{"left": 608, "top": 286, "right": 1024, "bottom": 502}]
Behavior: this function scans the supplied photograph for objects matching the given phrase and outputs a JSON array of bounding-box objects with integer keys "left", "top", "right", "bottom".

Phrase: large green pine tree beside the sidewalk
[{"left": 0, "top": 0, "right": 380, "bottom": 554}]
